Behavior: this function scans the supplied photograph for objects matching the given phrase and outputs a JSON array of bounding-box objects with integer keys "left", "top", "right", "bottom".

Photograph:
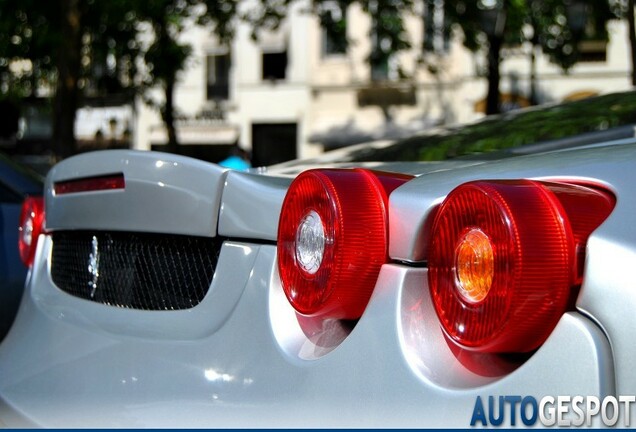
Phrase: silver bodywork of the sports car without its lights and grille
[{"left": 0, "top": 143, "right": 636, "bottom": 428}]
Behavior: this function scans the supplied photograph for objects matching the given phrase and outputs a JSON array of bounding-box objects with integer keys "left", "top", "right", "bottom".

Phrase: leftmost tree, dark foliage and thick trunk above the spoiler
[{"left": 0, "top": 0, "right": 142, "bottom": 157}]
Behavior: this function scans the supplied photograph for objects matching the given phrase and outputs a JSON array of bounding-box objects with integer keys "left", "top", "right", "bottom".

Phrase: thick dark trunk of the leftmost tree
[{"left": 53, "top": 0, "right": 82, "bottom": 159}]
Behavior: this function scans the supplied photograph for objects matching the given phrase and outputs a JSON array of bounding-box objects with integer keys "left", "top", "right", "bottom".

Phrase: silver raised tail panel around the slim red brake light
[{"left": 45, "top": 150, "right": 227, "bottom": 237}]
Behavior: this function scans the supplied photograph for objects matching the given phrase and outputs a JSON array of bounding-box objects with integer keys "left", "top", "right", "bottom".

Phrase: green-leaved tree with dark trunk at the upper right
[{"left": 444, "top": 0, "right": 615, "bottom": 114}]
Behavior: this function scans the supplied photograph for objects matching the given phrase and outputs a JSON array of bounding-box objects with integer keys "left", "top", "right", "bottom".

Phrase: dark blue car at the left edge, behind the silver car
[{"left": 0, "top": 154, "right": 43, "bottom": 340}]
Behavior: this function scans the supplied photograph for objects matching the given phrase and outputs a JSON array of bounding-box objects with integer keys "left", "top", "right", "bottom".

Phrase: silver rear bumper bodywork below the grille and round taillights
[{"left": 0, "top": 245, "right": 614, "bottom": 427}]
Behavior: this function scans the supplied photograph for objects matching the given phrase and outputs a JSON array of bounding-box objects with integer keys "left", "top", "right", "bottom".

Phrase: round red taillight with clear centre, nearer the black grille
[{"left": 278, "top": 169, "right": 412, "bottom": 319}]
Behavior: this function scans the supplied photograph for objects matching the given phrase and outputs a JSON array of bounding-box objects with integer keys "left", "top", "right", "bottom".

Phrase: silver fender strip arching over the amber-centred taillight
[{"left": 389, "top": 140, "right": 636, "bottom": 262}]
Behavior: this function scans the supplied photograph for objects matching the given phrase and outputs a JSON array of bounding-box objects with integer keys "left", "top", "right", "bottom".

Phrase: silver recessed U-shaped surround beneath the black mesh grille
[{"left": 26, "top": 236, "right": 258, "bottom": 340}]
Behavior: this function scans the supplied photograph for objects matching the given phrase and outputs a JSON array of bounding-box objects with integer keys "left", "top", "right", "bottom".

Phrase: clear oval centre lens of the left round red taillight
[{"left": 296, "top": 210, "right": 325, "bottom": 275}]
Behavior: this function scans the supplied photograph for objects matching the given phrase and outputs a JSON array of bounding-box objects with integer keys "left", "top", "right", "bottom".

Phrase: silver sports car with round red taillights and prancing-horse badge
[{"left": 0, "top": 94, "right": 636, "bottom": 428}]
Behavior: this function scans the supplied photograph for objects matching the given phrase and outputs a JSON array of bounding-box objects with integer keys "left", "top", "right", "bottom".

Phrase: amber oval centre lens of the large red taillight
[{"left": 455, "top": 228, "right": 495, "bottom": 303}]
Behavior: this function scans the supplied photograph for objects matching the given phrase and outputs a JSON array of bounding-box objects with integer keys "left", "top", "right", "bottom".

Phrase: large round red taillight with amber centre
[{"left": 429, "top": 180, "right": 615, "bottom": 352}]
